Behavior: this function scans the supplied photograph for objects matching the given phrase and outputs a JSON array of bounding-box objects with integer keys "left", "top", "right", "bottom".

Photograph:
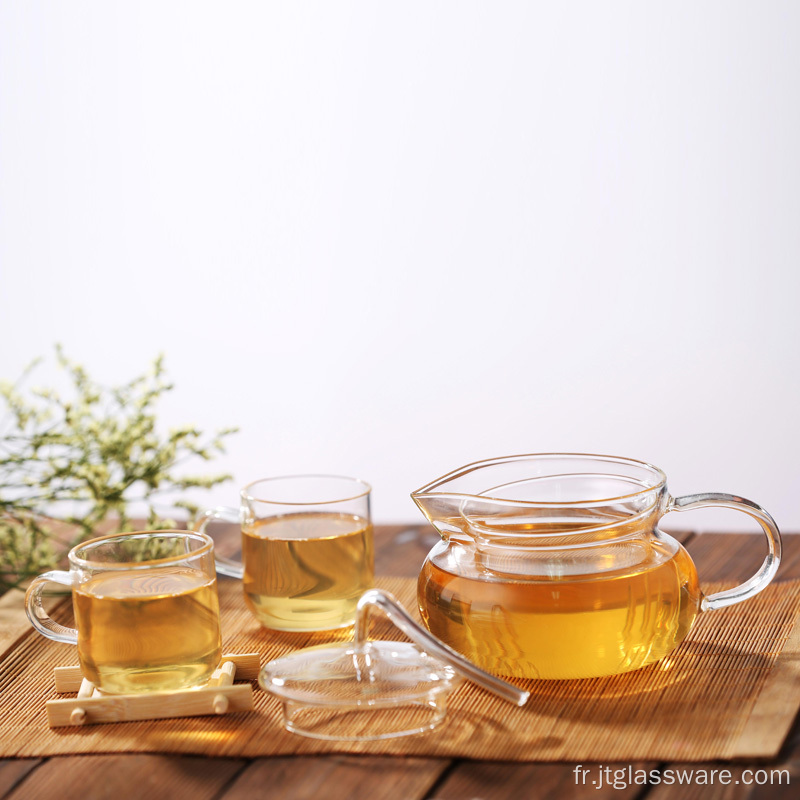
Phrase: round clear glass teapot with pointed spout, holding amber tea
[{"left": 411, "top": 453, "right": 781, "bottom": 678}]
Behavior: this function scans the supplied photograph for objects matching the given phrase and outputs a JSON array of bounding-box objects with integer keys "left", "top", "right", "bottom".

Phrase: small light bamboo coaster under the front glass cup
[{"left": 45, "top": 653, "right": 260, "bottom": 728}]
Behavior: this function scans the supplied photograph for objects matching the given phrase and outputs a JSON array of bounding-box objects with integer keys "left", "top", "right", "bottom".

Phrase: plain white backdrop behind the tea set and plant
[{"left": 0, "top": 0, "right": 800, "bottom": 530}]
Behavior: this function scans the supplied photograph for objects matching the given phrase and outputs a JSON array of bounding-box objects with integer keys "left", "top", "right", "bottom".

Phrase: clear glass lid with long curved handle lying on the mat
[{"left": 259, "top": 589, "right": 528, "bottom": 741}]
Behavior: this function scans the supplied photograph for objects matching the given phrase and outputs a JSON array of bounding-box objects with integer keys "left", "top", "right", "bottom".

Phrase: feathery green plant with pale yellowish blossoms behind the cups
[{"left": 0, "top": 346, "right": 236, "bottom": 591}]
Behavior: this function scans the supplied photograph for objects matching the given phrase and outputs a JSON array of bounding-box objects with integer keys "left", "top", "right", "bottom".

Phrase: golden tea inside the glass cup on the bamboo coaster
[{"left": 73, "top": 567, "right": 221, "bottom": 694}]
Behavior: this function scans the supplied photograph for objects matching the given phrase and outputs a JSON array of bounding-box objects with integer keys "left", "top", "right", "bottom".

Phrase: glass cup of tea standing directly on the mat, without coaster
[{"left": 198, "top": 475, "right": 375, "bottom": 631}]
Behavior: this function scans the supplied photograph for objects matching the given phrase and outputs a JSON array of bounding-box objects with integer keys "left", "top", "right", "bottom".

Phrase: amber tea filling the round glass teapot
[{"left": 419, "top": 537, "right": 701, "bottom": 678}]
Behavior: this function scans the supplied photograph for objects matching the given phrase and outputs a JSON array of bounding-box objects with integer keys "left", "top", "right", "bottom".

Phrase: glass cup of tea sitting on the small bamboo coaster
[{"left": 25, "top": 530, "right": 222, "bottom": 694}]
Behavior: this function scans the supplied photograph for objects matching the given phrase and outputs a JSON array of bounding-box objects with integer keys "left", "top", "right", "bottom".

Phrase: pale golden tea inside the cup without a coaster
[{"left": 242, "top": 513, "right": 374, "bottom": 631}]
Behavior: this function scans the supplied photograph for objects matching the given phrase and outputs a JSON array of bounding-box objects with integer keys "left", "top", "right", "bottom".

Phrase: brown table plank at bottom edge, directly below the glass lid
[{"left": 225, "top": 756, "right": 447, "bottom": 800}]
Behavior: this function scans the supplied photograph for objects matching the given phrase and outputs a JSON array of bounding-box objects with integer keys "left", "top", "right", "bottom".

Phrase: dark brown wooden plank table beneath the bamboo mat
[{"left": 0, "top": 525, "right": 800, "bottom": 800}]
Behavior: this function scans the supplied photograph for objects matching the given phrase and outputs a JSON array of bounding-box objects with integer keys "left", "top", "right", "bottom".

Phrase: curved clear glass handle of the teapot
[{"left": 667, "top": 492, "right": 781, "bottom": 611}]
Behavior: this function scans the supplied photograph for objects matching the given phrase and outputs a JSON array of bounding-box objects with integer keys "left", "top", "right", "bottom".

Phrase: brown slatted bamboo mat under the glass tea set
[{"left": 0, "top": 578, "right": 800, "bottom": 761}]
